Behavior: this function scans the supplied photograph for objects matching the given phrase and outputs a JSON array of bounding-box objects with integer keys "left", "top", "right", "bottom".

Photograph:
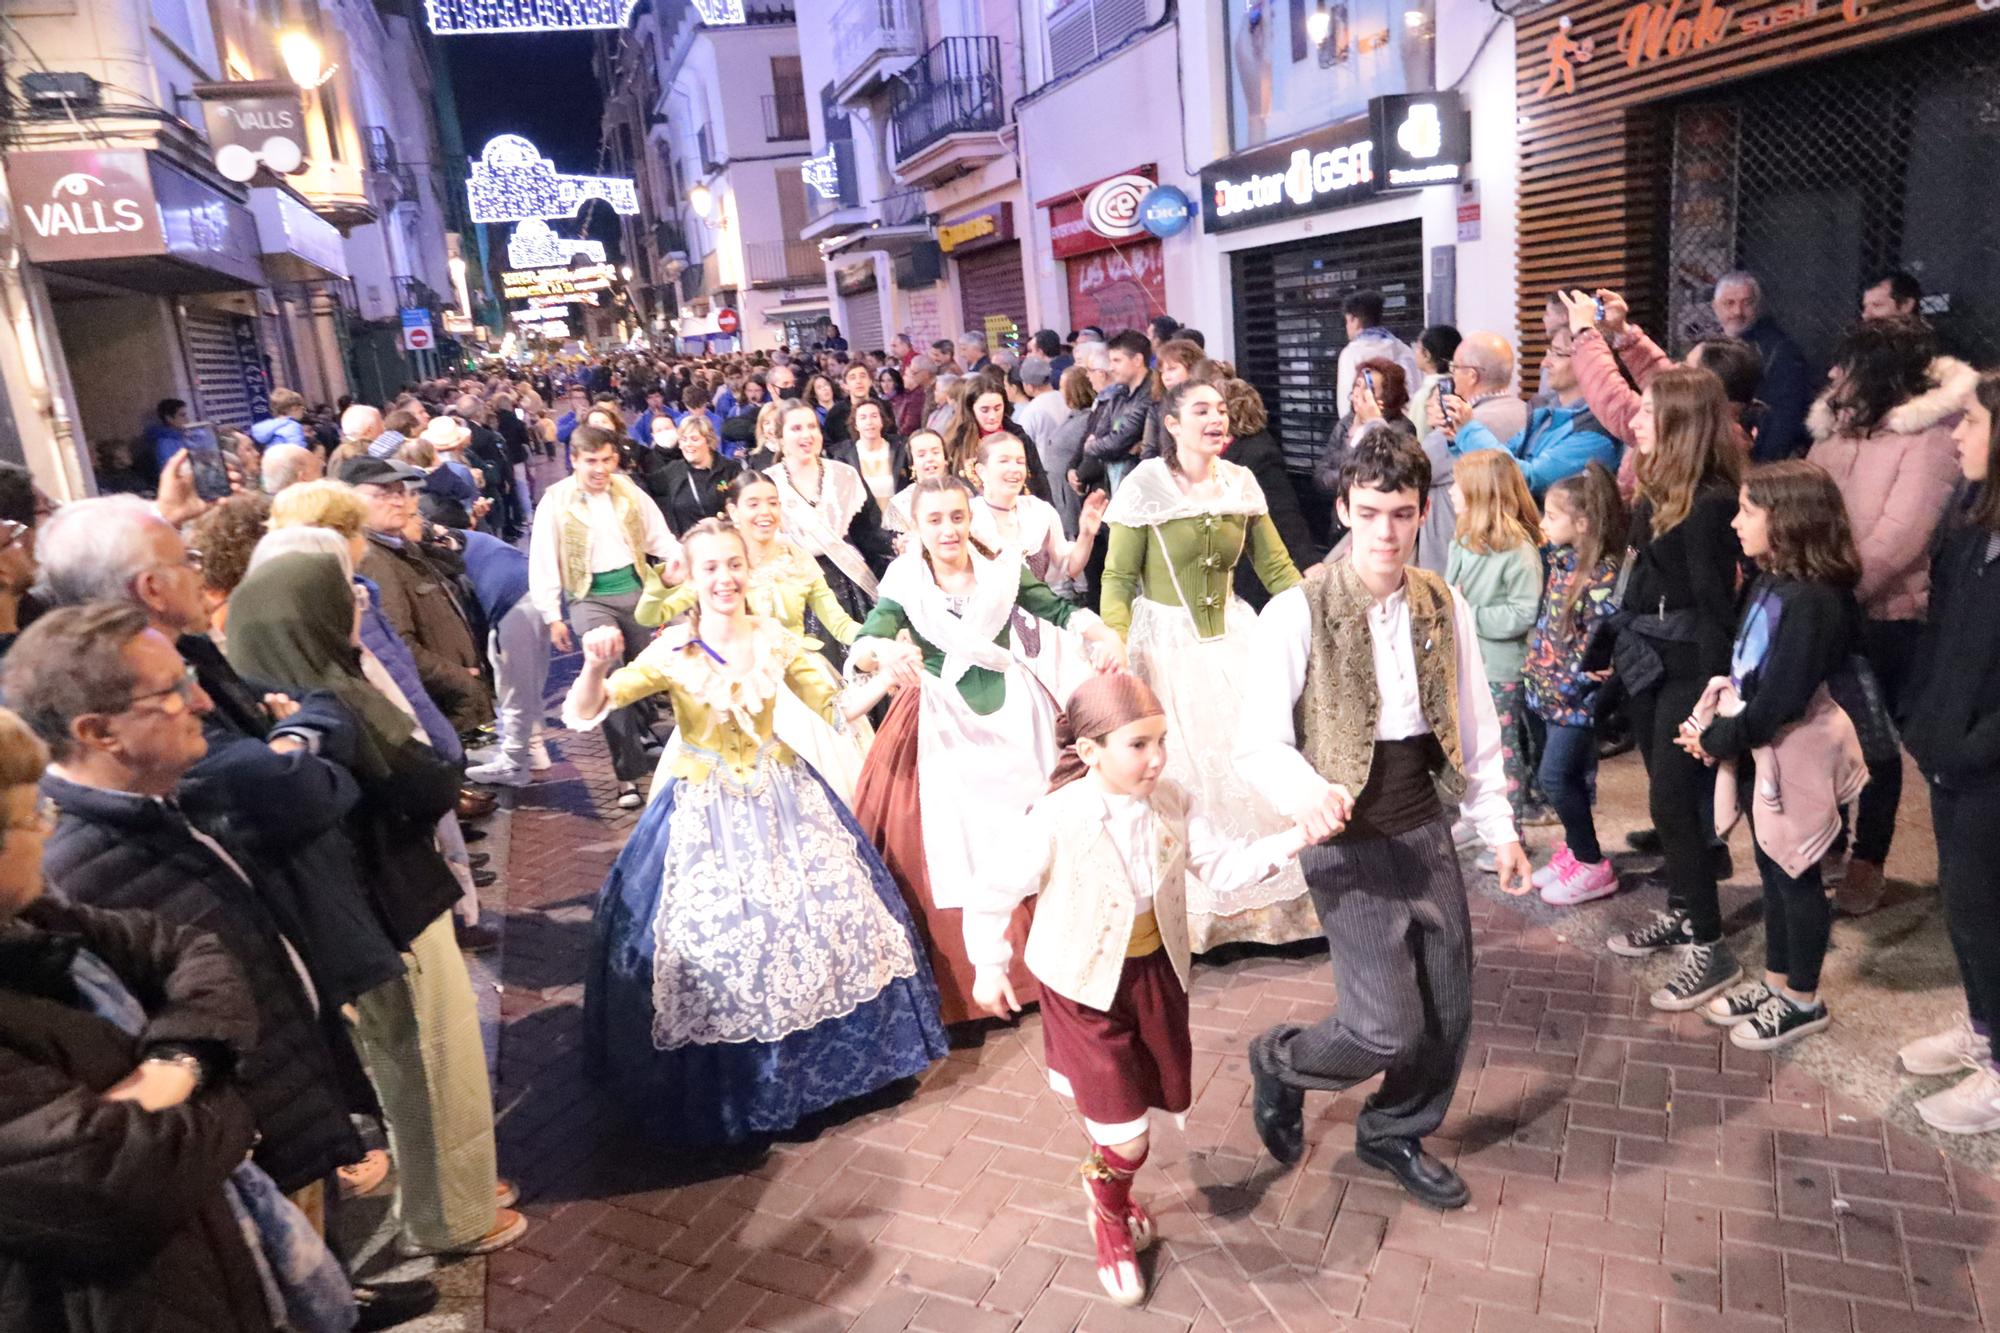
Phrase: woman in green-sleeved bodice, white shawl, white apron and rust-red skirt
[{"left": 848, "top": 476, "right": 1124, "bottom": 1023}]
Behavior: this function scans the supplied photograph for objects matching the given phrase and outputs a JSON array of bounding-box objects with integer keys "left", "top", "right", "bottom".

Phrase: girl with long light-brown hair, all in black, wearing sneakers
[{"left": 1608, "top": 366, "right": 1744, "bottom": 1011}]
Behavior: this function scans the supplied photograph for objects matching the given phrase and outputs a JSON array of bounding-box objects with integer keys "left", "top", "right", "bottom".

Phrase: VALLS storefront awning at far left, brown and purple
[{"left": 6, "top": 148, "right": 264, "bottom": 294}]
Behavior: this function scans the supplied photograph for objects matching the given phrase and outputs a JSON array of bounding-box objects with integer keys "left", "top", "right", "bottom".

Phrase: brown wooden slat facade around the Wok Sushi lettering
[{"left": 1514, "top": 0, "right": 2000, "bottom": 368}]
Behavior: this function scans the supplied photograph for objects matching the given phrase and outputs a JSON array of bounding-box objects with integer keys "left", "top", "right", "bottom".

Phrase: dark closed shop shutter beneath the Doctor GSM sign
[{"left": 1230, "top": 222, "right": 1424, "bottom": 472}]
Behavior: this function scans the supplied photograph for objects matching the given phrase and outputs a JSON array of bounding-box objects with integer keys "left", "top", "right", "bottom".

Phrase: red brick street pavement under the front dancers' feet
[{"left": 488, "top": 660, "right": 2000, "bottom": 1333}]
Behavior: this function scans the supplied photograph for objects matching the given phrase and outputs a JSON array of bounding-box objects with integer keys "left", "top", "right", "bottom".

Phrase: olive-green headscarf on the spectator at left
[{"left": 228, "top": 554, "right": 410, "bottom": 781}]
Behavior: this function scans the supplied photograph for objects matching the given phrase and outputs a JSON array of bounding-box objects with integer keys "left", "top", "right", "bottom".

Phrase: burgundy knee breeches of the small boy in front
[{"left": 1042, "top": 949, "right": 1194, "bottom": 1125}]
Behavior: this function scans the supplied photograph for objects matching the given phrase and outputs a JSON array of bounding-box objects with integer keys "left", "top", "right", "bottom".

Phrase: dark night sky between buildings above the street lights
[{"left": 438, "top": 32, "right": 616, "bottom": 253}]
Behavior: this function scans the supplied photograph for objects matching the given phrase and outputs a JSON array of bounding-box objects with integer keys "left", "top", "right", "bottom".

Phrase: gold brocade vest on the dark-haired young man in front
[{"left": 1294, "top": 560, "right": 1466, "bottom": 801}]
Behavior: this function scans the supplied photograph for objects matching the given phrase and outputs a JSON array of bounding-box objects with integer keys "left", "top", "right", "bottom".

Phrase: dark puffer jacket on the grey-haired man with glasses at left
[{"left": 42, "top": 773, "right": 364, "bottom": 1193}]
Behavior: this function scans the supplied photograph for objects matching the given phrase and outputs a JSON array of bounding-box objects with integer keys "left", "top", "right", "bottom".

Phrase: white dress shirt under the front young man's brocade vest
[{"left": 1236, "top": 586, "right": 1520, "bottom": 847}]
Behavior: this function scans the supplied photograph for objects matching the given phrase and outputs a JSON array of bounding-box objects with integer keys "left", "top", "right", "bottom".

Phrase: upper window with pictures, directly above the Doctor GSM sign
[{"left": 1222, "top": 0, "right": 1438, "bottom": 148}]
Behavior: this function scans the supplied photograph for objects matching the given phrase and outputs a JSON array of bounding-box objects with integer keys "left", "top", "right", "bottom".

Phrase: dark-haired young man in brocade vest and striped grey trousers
[{"left": 1236, "top": 432, "right": 1530, "bottom": 1209}]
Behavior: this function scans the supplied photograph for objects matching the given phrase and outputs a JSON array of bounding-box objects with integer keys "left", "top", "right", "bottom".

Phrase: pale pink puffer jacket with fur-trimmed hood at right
[{"left": 1806, "top": 356, "right": 1978, "bottom": 620}]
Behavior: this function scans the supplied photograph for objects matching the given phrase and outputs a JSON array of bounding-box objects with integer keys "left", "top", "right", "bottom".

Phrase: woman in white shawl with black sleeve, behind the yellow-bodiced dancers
[{"left": 764, "top": 402, "right": 894, "bottom": 620}]
